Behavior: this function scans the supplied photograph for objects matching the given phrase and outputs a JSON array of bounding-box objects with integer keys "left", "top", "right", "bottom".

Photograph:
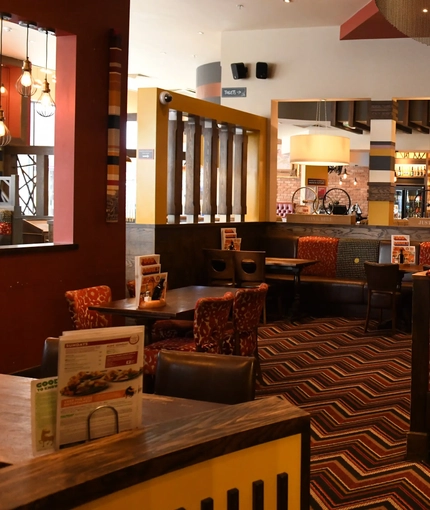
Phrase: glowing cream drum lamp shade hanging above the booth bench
[{"left": 290, "top": 135, "right": 350, "bottom": 166}]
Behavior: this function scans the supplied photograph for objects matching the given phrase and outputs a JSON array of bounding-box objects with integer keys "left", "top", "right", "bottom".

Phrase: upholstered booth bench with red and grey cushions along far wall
[{"left": 266, "top": 235, "right": 424, "bottom": 316}]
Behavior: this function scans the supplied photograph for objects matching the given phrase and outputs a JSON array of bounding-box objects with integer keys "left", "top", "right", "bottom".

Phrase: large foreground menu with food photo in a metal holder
[{"left": 55, "top": 326, "right": 144, "bottom": 449}]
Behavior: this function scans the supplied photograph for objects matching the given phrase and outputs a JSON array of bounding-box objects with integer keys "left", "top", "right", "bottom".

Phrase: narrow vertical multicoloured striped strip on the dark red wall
[{"left": 106, "top": 30, "right": 122, "bottom": 222}]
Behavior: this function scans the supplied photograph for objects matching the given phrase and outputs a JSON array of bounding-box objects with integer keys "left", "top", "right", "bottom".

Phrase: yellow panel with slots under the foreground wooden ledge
[{"left": 77, "top": 434, "right": 301, "bottom": 510}]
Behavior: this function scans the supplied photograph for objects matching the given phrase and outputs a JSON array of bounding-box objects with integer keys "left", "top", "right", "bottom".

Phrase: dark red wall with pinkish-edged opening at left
[{"left": 0, "top": 0, "right": 129, "bottom": 373}]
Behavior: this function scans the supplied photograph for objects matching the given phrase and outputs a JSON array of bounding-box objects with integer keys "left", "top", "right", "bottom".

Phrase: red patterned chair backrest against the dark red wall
[{"left": 65, "top": 285, "right": 112, "bottom": 329}]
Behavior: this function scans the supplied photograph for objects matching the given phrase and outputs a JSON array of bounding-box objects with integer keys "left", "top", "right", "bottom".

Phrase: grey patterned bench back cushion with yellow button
[{"left": 336, "top": 237, "right": 379, "bottom": 280}]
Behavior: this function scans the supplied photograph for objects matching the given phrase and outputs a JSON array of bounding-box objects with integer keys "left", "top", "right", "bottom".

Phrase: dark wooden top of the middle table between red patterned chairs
[{"left": 89, "top": 285, "right": 237, "bottom": 319}]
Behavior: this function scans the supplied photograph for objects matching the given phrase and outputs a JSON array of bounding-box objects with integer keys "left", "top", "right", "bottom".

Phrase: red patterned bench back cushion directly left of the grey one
[{"left": 297, "top": 236, "right": 339, "bottom": 278}]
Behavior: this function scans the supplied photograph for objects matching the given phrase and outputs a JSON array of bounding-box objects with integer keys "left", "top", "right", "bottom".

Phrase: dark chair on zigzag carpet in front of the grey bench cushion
[{"left": 364, "top": 261, "right": 402, "bottom": 334}]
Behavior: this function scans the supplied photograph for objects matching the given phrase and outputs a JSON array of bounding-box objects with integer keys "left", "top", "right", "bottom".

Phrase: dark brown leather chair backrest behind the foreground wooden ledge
[{"left": 154, "top": 350, "right": 255, "bottom": 404}]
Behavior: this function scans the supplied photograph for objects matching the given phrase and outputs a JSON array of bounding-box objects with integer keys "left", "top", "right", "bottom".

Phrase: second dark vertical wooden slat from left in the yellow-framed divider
[{"left": 184, "top": 116, "right": 202, "bottom": 223}]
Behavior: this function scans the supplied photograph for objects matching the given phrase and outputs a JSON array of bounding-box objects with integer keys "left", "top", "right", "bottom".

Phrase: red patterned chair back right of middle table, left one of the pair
[{"left": 193, "top": 292, "right": 234, "bottom": 353}]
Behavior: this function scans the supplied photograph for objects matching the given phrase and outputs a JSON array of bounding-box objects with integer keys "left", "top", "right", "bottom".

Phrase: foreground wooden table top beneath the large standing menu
[{"left": 0, "top": 374, "right": 224, "bottom": 467}]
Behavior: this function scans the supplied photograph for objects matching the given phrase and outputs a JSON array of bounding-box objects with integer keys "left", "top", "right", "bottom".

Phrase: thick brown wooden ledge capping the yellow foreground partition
[{"left": 0, "top": 397, "right": 310, "bottom": 510}]
